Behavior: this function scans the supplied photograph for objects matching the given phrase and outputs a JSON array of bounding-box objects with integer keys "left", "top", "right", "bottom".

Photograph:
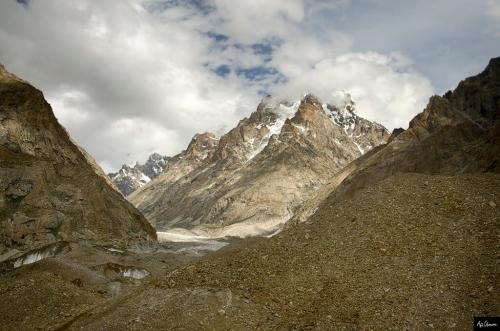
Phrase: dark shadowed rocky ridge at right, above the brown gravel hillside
[{"left": 330, "top": 58, "right": 500, "bottom": 200}]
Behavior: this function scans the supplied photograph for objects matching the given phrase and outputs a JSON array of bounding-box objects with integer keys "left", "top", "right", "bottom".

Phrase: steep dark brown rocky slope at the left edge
[{"left": 0, "top": 66, "right": 156, "bottom": 253}]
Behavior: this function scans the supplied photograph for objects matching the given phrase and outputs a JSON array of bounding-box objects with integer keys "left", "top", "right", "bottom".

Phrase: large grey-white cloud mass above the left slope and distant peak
[{"left": 0, "top": 0, "right": 258, "bottom": 170}]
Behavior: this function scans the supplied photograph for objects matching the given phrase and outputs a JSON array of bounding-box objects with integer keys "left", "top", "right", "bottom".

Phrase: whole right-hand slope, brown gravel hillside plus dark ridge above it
[{"left": 65, "top": 59, "right": 500, "bottom": 330}]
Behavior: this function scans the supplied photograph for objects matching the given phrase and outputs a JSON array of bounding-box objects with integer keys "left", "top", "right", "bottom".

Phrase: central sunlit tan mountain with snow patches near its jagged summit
[{"left": 129, "top": 94, "right": 389, "bottom": 236}]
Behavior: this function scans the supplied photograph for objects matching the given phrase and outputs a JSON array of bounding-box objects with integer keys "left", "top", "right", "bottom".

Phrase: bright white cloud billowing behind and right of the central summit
[{"left": 270, "top": 52, "right": 432, "bottom": 129}]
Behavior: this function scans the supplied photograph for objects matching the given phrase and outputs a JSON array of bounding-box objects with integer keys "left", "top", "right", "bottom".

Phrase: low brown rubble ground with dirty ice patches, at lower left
[{"left": 0, "top": 241, "right": 203, "bottom": 330}]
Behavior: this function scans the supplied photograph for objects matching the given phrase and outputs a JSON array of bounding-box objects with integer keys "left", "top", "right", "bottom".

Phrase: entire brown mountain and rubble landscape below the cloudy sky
[{"left": 0, "top": 58, "right": 500, "bottom": 330}]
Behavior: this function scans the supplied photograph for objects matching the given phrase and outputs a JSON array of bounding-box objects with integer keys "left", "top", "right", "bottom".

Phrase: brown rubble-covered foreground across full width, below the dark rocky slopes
[{"left": 0, "top": 173, "right": 500, "bottom": 330}]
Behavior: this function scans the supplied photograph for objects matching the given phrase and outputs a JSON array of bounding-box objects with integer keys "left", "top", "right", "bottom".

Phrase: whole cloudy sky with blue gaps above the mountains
[{"left": 0, "top": 0, "right": 500, "bottom": 171}]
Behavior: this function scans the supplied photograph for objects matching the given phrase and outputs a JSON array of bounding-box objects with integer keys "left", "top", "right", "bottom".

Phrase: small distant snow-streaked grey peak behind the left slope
[{"left": 108, "top": 153, "right": 170, "bottom": 196}]
